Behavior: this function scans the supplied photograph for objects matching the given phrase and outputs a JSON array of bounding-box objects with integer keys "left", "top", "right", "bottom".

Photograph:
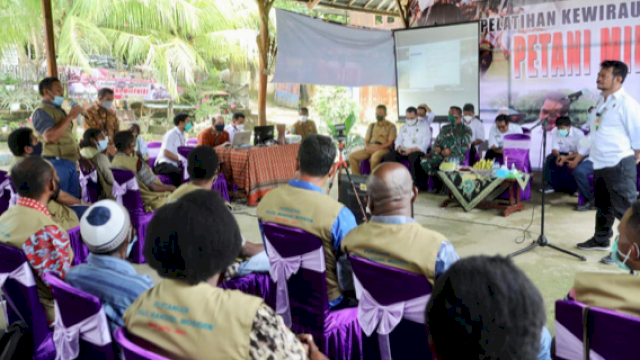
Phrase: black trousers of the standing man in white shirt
[{"left": 594, "top": 156, "right": 638, "bottom": 246}]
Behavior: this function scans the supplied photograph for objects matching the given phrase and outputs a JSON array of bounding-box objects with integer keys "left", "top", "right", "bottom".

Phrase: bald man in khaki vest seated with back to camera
[{"left": 342, "top": 163, "right": 459, "bottom": 285}]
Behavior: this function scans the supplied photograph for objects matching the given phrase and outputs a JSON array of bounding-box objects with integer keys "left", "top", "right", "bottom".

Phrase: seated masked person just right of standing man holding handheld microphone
[{"left": 80, "top": 129, "right": 113, "bottom": 199}]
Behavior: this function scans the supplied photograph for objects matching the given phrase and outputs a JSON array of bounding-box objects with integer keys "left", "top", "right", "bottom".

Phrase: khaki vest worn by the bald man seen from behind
[{"left": 342, "top": 221, "right": 445, "bottom": 285}]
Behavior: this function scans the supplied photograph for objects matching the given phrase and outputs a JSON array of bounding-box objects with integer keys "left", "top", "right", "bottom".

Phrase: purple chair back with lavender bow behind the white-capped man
[{"left": 44, "top": 273, "right": 115, "bottom": 360}]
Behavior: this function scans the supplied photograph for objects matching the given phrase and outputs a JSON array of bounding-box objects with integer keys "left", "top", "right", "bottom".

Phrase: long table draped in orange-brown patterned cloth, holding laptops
[{"left": 216, "top": 144, "right": 300, "bottom": 206}]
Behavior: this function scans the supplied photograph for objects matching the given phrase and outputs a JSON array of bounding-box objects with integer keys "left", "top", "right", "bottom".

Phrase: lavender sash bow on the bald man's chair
[{"left": 353, "top": 274, "right": 431, "bottom": 360}]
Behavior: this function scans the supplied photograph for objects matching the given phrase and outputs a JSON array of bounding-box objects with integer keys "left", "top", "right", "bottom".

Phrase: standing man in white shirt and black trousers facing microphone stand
[{"left": 578, "top": 61, "right": 640, "bottom": 264}]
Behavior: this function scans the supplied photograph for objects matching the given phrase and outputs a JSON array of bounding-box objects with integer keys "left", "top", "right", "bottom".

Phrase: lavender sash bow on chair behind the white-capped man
[{"left": 53, "top": 302, "right": 111, "bottom": 360}]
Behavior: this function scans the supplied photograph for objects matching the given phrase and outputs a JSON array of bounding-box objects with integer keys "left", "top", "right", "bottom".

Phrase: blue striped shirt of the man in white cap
[{"left": 65, "top": 254, "right": 153, "bottom": 332}]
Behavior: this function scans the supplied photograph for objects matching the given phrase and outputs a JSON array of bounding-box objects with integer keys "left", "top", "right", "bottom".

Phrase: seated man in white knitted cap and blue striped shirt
[{"left": 65, "top": 200, "right": 153, "bottom": 332}]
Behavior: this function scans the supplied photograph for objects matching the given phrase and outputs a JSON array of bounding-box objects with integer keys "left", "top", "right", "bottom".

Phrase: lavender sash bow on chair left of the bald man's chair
[{"left": 265, "top": 239, "right": 326, "bottom": 327}]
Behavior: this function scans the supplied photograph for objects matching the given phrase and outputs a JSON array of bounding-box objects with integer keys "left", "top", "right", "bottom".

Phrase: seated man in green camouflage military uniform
[{"left": 422, "top": 106, "right": 471, "bottom": 176}]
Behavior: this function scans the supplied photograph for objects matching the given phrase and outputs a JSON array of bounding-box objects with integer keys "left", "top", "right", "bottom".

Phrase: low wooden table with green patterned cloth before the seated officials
[{"left": 438, "top": 171, "right": 531, "bottom": 216}]
